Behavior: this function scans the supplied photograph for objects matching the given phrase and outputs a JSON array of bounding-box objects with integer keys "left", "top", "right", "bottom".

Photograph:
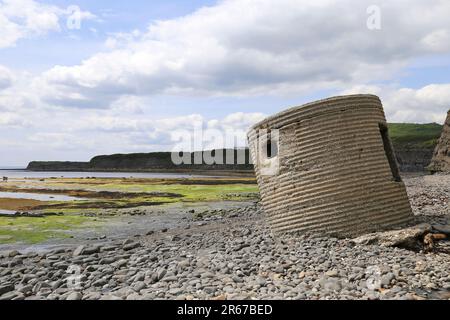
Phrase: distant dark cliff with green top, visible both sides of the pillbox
[{"left": 27, "top": 123, "right": 442, "bottom": 172}]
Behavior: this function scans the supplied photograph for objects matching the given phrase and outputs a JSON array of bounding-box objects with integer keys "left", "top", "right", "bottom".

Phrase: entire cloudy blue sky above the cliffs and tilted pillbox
[{"left": 0, "top": 0, "right": 450, "bottom": 167}]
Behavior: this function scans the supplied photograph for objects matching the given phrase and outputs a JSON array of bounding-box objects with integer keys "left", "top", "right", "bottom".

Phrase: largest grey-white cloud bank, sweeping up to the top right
[{"left": 34, "top": 0, "right": 450, "bottom": 108}]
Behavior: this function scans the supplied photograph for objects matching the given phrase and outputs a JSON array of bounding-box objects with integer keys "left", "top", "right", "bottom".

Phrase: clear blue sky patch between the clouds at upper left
[{"left": 0, "top": 0, "right": 215, "bottom": 71}]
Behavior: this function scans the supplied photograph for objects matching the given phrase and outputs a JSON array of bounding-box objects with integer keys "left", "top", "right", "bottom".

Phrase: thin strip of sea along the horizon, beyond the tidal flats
[{"left": 0, "top": 169, "right": 221, "bottom": 179}]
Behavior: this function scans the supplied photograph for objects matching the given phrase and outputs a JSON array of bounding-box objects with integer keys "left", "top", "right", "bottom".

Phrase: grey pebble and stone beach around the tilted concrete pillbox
[{"left": 0, "top": 175, "right": 450, "bottom": 300}]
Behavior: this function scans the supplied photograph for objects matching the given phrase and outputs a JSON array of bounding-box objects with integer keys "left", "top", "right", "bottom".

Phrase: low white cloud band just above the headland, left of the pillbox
[{"left": 39, "top": 111, "right": 265, "bottom": 153}]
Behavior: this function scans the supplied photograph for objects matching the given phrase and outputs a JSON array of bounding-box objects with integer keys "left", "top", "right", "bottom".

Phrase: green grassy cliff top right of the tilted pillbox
[{"left": 388, "top": 123, "right": 442, "bottom": 149}]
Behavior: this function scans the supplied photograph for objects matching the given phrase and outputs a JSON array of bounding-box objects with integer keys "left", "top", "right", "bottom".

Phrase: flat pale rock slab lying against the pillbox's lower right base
[{"left": 352, "top": 223, "right": 432, "bottom": 247}]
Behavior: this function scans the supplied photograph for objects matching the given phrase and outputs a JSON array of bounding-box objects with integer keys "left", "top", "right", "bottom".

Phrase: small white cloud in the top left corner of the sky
[{"left": 0, "top": 0, "right": 96, "bottom": 49}]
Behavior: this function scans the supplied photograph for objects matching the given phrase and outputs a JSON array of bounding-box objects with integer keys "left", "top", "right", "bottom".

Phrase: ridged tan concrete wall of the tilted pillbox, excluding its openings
[{"left": 248, "top": 95, "right": 412, "bottom": 237}]
